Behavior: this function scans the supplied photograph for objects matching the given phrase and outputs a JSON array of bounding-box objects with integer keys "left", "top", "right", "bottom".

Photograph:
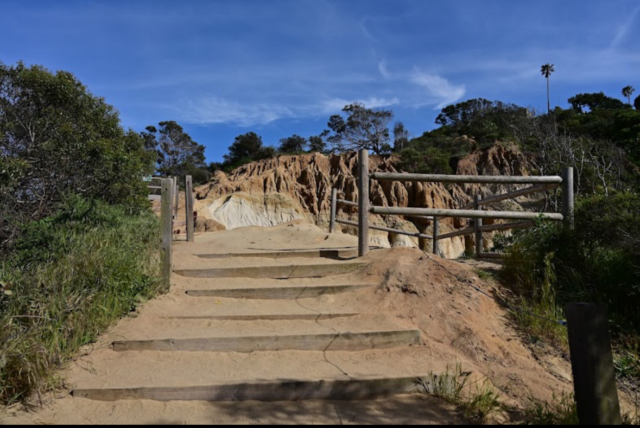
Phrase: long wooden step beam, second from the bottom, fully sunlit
[{"left": 112, "top": 330, "right": 420, "bottom": 353}]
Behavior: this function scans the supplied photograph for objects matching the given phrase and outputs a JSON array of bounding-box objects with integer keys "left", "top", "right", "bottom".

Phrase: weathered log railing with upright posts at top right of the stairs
[{"left": 329, "top": 150, "right": 574, "bottom": 258}]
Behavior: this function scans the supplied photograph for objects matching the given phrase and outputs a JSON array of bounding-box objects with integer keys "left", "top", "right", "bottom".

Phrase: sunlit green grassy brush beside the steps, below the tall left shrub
[{"left": 0, "top": 198, "right": 160, "bottom": 403}]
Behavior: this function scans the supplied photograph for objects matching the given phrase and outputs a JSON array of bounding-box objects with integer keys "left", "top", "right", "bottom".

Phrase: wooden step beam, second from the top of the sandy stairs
[{"left": 174, "top": 262, "right": 368, "bottom": 279}]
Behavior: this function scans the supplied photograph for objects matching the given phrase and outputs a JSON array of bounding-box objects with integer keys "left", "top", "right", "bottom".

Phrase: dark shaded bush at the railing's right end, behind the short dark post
[{"left": 504, "top": 193, "right": 640, "bottom": 375}]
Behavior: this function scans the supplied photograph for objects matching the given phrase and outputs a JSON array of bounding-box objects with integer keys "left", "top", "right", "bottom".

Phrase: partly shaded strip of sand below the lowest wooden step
[{"left": 0, "top": 395, "right": 468, "bottom": 425}]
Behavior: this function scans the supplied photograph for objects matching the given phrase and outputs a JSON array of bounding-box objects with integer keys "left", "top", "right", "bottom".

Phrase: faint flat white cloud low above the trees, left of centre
[{"left": 181, "top": 97, "right": 295, "bottom": 126}]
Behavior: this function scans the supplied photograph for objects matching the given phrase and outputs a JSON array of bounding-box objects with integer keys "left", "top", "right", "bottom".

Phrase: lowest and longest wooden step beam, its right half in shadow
[{"left": 72, "top": 376, "right": 423, "bottom": 401}]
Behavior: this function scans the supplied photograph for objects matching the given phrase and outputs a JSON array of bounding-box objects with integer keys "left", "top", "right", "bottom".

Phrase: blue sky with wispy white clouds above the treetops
[{"left": 0, "top": 0, "right": 640, "bottom": 161}]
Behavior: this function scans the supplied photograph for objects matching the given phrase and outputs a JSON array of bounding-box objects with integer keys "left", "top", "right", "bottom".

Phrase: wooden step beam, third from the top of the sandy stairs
[{"left": 186, "top": 284, "right": 376, "bottom": 300}]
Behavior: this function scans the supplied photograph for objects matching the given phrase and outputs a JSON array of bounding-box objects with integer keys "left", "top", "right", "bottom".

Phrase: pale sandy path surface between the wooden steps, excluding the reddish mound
[{"left": 0, "top": 223, "right": 476, "bottom": 424}]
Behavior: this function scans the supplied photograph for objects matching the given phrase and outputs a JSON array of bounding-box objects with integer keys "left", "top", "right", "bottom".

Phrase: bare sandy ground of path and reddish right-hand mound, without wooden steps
[{"left": 0, "top": 222, "right": 636, "bottom": 424}]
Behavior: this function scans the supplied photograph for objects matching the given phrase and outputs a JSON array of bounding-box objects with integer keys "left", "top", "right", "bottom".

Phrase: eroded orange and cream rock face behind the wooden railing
[{"left": 196, "top": 145, "right": 528, "bottom": 258}]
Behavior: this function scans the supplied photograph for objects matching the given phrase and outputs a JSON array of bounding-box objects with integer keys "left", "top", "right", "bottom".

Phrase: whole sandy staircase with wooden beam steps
[{"left": 68, "top": 232, "right": 436, "bottom": 402}]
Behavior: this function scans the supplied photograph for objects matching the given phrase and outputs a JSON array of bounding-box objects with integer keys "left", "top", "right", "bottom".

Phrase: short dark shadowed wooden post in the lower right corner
[{"left": 565, "top": 303, "right": 622, "bottom": 425}]
